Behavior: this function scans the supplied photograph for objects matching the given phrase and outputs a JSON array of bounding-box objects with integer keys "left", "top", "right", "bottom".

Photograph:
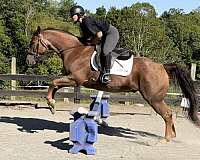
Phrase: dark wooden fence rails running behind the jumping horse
[{"left": 0, "top": 74, "right": 199, "bottom": 105}]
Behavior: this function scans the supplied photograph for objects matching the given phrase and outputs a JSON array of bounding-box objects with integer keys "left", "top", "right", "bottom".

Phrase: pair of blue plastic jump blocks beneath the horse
[{"left": 69, "top": 93, "right": 110, "bottom": 155}]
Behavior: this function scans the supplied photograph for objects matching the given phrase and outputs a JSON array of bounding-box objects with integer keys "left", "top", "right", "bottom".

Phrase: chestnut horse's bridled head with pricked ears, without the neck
[{"left": 26, "top": 26, "right": 51, "bottom": 65}]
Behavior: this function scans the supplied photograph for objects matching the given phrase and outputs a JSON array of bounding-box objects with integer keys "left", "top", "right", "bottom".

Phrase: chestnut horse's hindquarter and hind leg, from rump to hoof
[{"left": 139, "top": 61, "right": 176, "bottom": 143}]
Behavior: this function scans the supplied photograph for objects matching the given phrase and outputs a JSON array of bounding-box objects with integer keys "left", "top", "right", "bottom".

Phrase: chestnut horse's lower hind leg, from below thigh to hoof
[{"left": 149, "top": 100, "right": 176, "bottom": 143}]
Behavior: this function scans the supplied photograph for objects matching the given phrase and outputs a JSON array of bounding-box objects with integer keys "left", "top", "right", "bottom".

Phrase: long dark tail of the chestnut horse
[{"left": 163, "top": 64, "right": 200, "bottom": 126}]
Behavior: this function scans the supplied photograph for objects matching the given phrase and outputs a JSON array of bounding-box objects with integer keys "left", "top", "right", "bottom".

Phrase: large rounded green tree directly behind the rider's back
[{"left": 106, "top": 3, "right": 180, "bottom": 63}]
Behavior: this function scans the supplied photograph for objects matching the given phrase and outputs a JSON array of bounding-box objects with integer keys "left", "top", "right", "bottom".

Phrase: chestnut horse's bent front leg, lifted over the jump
[{"left": 46, "top": 76, "right": 76, "bottom": 114}]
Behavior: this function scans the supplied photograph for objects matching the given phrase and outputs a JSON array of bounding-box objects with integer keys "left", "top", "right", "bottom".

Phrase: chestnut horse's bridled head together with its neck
[{"left": 26, "top": 26, "right": 83, "bottom": 65}]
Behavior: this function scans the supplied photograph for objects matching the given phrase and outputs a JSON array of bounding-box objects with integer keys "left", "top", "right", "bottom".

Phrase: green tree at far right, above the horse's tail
[{"left": 161, "top": 8, "right": 199, "bottom": 65}]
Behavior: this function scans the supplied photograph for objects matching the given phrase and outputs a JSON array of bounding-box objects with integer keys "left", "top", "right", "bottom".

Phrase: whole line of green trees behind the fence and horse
[{"left": 0, "top": 0, "right": 200, "bottom": 87}]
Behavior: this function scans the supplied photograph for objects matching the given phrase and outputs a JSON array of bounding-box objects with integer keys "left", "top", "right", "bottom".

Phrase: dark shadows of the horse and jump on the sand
[{"left": 0, "top": 117, "right": 161, "bottom": 150}]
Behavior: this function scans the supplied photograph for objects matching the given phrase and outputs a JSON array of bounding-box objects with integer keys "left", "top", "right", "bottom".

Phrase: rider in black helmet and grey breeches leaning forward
[{"left": 70, "top": 5, "right": 119, "bottom": 84}]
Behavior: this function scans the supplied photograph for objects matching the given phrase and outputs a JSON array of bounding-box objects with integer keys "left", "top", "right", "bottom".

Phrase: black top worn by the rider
[{"left": 80, "top": 17, "right": 110, "bottom": 40}]
